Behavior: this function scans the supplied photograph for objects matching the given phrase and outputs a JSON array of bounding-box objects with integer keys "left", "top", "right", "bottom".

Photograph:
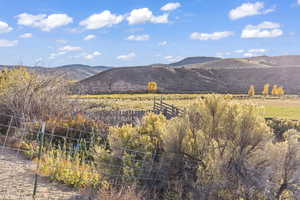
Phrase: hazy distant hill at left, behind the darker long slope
[{"left": 0, "top": 64, "right": 111, "bottom": 81}]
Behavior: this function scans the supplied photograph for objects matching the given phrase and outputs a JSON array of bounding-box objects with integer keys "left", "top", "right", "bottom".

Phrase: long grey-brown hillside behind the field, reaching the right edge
[{"left": 74, "top": 56, "right": 300, "bottom": 94}]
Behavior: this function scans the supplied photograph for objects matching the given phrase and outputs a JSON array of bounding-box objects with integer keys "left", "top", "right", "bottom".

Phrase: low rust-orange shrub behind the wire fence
[{"left": 27, "top": 114, "right": 108, "bottom": 149}]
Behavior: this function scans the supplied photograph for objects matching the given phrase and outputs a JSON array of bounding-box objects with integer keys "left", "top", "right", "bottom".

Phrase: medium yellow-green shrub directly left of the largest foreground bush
[{"left": 94, "top": 113, "right": 167, "bottom": 192}]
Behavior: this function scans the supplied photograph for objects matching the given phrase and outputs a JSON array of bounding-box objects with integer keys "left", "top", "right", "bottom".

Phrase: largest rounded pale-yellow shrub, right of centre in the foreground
[{"left": 159, "top": 95, "right": 271, "bottom": 199}]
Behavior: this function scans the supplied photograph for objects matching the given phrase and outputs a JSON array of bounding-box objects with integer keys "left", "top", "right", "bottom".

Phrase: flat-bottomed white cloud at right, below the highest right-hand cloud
[{"left": 241, "top": 21, "right": 283, "bottom": 38}]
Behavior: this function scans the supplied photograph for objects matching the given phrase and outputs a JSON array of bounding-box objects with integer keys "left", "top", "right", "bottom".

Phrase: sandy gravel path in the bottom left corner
[{"left": 0, "top": 148, "right": 84, "bottom": 200}]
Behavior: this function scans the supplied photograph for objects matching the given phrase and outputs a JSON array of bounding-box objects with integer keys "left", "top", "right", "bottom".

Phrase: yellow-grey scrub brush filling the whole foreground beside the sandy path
[{"left": 0, "top": 69, "right": 300, "bottom": 200}]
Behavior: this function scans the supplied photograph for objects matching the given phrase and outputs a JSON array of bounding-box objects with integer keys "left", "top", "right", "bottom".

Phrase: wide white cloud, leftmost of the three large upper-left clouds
[{"left": 16, "top": 13, "right": 73, "bottom": 31}]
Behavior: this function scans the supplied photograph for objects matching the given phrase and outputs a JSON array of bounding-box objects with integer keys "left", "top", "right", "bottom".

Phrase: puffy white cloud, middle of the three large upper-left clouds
[{"left": 80, "top": 10, "right": 124, "bottom": 29}]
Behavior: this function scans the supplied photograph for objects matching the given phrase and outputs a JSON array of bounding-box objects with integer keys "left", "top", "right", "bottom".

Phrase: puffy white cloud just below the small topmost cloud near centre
[{"left": 127, "top": 8, "right": 169, "bottom": 25}]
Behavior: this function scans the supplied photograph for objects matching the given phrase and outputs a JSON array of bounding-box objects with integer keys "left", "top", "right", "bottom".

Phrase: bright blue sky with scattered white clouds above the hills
[{"left": 0, "top": 0, "right": 300, "bottom": 67}]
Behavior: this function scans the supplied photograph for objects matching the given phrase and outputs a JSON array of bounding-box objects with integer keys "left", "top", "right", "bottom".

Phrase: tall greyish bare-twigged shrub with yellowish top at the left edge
[{"left": 0, "top": 68, "right": 73, "bottom": 126}]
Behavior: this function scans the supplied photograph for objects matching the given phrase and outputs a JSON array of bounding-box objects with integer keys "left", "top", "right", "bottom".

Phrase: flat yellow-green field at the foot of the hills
[{"left": 71, "top": 94, "right": 300, "bottom": 120}]
